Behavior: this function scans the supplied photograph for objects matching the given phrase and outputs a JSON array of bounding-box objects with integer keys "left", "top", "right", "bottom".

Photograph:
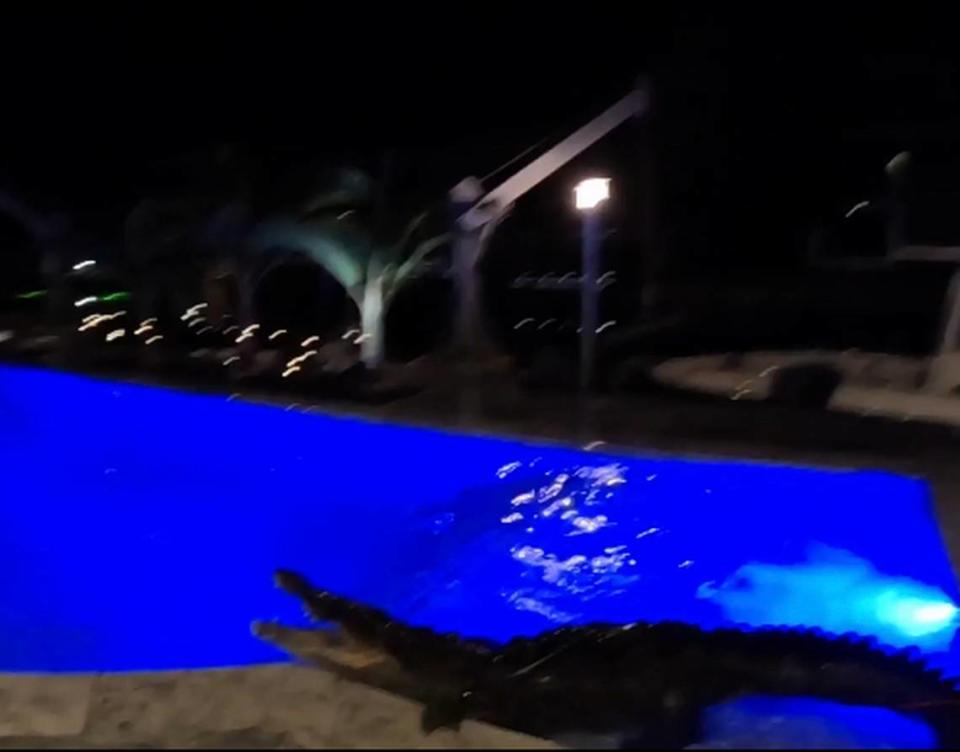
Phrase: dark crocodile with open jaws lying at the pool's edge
[{"left": 254, "top": 571, "right": 960, "bottom": 748}]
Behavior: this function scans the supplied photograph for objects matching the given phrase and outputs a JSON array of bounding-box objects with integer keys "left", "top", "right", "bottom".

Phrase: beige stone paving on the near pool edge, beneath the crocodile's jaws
[{"left": 0, "top": 664, "right": 557, "bottom": 749}]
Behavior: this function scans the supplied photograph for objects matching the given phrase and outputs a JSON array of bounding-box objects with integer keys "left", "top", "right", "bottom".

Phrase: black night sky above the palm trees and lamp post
[{"left": 0, "top": 3, "right": 960, "bottom": 274}]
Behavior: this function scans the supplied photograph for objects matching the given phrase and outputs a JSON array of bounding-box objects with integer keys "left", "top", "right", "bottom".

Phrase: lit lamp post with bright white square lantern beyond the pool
[{"left": 574, "top": 178, "right": 610, "bottom": 391}]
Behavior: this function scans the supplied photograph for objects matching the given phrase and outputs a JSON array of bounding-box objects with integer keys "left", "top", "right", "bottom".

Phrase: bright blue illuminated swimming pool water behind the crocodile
[{"left": 0, "top": 368, "right": 958, "bottom": 671}]
